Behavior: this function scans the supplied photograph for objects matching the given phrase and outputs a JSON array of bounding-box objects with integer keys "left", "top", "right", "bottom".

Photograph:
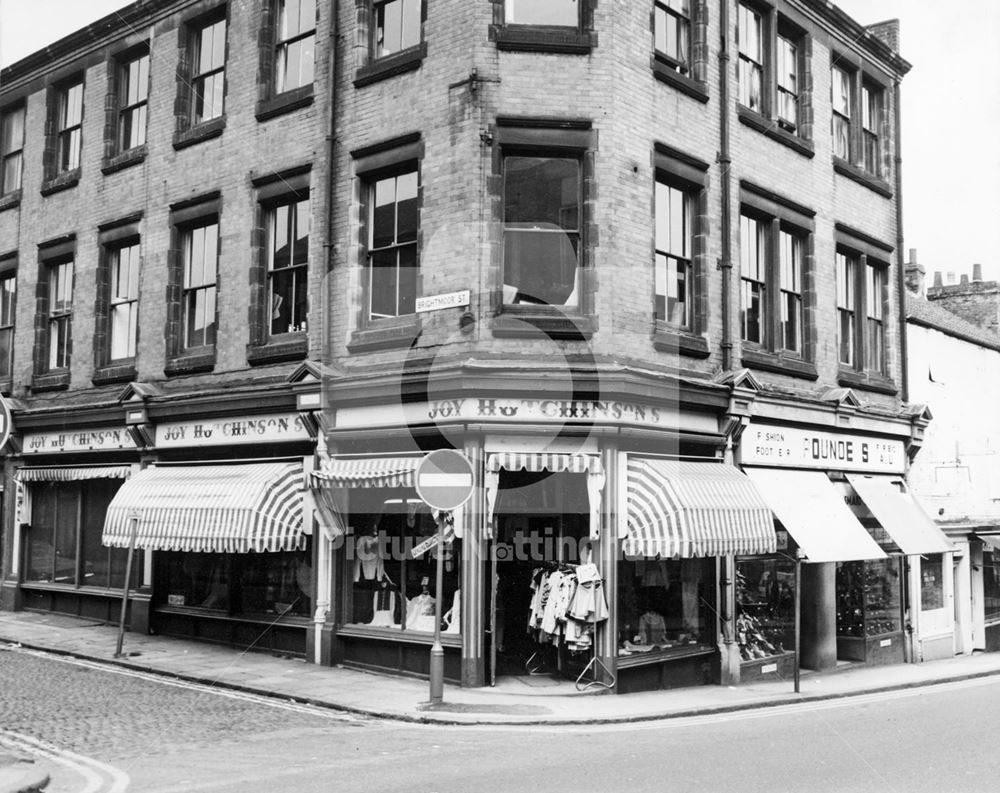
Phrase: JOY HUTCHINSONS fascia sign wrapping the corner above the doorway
[{"left": 337, "top": 397, "right": 718, "bottom": 432}]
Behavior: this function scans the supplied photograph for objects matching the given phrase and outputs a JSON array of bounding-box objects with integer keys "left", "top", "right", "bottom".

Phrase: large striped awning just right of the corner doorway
[{"left": 622, "top": 456, "right": 776, "bottom": 558}]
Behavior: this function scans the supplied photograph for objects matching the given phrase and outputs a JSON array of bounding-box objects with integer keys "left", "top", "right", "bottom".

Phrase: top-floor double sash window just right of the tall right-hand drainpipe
[{"left": 737, "top": 3, "right": 812, "bottom": 140}]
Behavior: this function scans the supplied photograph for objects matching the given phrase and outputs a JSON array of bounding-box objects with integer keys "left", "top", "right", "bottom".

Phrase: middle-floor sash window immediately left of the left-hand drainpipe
[{"left": 267, "top": 199, "right": 310, "bottom": 336}]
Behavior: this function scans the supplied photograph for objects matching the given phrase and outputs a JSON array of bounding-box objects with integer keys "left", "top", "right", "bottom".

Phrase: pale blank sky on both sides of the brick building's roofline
[{"left": 0, "top": 0, "right": 1000, "bottom": 279}]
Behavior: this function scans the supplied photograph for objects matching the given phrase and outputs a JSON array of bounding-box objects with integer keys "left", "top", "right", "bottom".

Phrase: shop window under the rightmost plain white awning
[{"left": 837, "top": 557, "right": 902, "bottom": 638}]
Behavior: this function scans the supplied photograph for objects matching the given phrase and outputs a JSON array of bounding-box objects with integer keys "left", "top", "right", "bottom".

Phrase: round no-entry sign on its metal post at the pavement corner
[{"left": 414, "top": 449, "right": 475, "bottom": 705}]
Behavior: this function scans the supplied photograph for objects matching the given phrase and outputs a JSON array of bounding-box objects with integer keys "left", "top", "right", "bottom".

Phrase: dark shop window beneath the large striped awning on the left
[{"left": 162, "top": 550, "right": 312, "bottom": 618}]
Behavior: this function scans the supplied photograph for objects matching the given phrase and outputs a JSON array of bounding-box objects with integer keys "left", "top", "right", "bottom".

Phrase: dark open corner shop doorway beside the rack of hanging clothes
[{"left": 486, "top": 470, "right": 590, "bottom": 685}]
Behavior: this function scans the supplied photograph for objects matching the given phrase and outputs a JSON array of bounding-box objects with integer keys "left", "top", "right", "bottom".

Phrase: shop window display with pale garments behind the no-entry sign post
[{"left": 346, "top": 490, "right": 461, "bottom": 633}]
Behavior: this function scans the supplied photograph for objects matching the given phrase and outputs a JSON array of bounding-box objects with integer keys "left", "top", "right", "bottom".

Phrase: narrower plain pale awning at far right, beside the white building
[{"left": 847, "top": 474, "right": 955, "bottom": 555}]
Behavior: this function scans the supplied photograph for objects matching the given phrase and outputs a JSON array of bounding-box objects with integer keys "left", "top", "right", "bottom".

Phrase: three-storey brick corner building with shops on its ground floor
[{"left": 0, "top": 0, "right": 945, "bottom": 691}]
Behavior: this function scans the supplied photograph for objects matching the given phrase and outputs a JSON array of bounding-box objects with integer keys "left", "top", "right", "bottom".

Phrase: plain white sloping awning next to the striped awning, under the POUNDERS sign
[{"left": 746, "top": 468, "right": 886, "bottom": 562}]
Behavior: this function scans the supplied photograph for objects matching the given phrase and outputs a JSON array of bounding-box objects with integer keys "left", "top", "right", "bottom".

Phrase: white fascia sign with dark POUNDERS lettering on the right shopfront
[{"left": 740, "top": 422, "right": 906, "bottom": 473}]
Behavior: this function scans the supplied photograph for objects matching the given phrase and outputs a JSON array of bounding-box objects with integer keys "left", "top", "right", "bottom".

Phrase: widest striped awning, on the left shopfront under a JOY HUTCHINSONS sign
[{"left": 101, "top": 462, "right": 308, "bottom": 553}]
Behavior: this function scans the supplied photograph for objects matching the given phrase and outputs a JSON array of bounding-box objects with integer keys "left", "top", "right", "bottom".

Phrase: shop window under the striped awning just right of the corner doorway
[{"left": 618, "top": 558, "right": 715, "bottom": 655}]
